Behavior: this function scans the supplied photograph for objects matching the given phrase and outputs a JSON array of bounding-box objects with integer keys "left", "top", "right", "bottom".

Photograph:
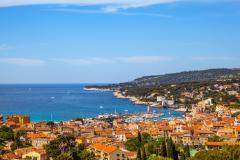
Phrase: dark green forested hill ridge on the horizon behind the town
[{"left": 118, "top": 69, "right": 240, "bottom": 87}]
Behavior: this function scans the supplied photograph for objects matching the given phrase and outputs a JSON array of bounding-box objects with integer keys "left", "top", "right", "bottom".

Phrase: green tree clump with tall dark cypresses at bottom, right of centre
[{"left": 125, "top": 133, "right": 190, "bottom": 160}]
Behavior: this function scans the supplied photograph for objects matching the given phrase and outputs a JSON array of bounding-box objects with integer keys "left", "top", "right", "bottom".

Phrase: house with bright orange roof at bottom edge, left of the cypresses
[{"left": 90, "top": 143, "right": 127, "bottom": 160}]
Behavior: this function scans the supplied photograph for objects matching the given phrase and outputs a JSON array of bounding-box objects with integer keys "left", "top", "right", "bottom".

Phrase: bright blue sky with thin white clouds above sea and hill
[{"left": 0, "top": 0, "right": 240, "bottom": 83}]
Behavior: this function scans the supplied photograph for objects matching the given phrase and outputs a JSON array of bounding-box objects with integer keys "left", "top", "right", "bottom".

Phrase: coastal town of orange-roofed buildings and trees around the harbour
[{"left": 0, "top": 80, "right": 240, "bottom": 160}]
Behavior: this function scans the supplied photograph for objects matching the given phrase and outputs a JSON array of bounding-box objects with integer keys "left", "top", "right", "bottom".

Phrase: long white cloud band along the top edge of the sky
[{"left": 0, "top": 0, "right": 236, "bottom": 12}]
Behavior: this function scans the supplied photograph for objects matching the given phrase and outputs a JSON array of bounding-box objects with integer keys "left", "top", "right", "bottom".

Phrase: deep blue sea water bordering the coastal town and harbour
[{"left": 0, "top": 84, "right": 182, "bottom": 121}]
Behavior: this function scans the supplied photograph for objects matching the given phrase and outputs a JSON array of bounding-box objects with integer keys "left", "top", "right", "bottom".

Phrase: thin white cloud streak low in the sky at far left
[{"left": 0, "top": 58, "right": 45, "bottom": 65}]
